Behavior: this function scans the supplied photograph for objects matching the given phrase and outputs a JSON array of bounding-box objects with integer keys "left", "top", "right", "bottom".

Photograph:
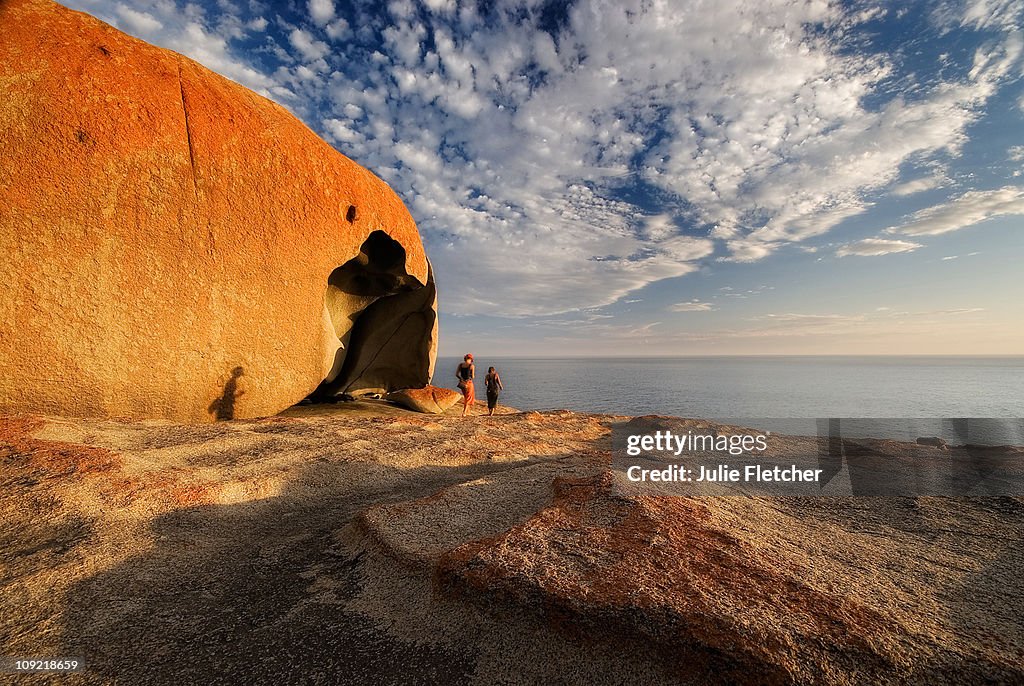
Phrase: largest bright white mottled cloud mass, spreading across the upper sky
[{"left": 327, "top": 0, "right": 991, "bottom": 313}]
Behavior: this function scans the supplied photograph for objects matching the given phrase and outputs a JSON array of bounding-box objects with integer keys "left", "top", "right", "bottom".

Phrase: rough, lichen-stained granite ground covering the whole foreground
[{"left": 0, "top": 401, "right": 1024, "bottom": 684}]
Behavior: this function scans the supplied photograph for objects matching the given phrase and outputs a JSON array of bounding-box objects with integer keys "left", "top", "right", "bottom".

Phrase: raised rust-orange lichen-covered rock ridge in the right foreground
[{"left": 438, "top": 473, "right": 902, "bottom": 683}]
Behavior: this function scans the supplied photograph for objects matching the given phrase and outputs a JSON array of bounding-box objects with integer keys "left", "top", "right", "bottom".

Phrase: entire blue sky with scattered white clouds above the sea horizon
[{"left": 69, "top": 0, "right": 1024, "bottom": 356}]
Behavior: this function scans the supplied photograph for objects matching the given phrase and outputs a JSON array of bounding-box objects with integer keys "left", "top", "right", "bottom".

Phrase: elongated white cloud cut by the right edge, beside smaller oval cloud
[{"left": 887, "top": 186, "right": 1024, "bottom": 235}]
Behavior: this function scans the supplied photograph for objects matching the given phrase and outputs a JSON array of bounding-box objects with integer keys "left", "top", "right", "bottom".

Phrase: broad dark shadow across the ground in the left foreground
[{"left": 63, "top": 454, "right": 544, "bottom": 684}]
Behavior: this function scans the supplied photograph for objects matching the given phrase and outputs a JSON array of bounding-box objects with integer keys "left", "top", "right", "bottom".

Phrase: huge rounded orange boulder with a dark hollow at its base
[{"left": 0, "top": 0, "right": 436, "bottom": 421}]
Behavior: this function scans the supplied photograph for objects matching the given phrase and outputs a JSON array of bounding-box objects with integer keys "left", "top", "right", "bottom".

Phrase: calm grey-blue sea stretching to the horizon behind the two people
[{"left": 433, "top": 356, "right": 1024, "bottom": 444}]
